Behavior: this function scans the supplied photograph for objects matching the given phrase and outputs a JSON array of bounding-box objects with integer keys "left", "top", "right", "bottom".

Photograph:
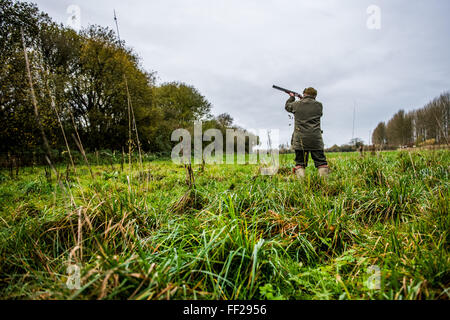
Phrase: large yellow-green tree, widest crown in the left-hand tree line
[{"left": 68, "top": 26, "right": 159, "bottom": 149}]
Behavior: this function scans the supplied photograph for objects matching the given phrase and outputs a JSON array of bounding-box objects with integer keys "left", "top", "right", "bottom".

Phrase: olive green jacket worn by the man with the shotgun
[{"left": 286, "top": 97, "right": 324, "bottom": 151}]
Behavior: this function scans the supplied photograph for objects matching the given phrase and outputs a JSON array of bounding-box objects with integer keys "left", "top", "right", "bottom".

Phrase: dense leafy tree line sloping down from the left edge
[{"left": 0, "top": 0, "right": 253, "bottom": 165}]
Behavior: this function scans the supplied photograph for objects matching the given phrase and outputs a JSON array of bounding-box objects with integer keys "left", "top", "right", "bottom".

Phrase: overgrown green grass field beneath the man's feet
[{"left": 0, "top": 150, "right": 450, "bottom": 299}]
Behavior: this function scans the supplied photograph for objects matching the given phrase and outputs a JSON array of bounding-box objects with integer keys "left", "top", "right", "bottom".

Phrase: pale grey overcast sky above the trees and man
[{"left": 29, "top": 0, "right": 450, "bottom": 147}]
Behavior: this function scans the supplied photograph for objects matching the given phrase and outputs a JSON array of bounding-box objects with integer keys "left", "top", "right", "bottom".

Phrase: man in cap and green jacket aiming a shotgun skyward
[{"left": 274, "top": 86, "right": 329, "bottom": 178}]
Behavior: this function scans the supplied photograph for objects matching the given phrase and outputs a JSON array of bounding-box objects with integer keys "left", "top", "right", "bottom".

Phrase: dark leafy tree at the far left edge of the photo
[{"left": 0, "top": 0, "right": 54, "bottom": 153}]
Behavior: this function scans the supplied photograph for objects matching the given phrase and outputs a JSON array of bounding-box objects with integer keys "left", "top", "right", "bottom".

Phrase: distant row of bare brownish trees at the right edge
[{"left": 372, "top": 92, "right": 450, "bottom": 148}]
